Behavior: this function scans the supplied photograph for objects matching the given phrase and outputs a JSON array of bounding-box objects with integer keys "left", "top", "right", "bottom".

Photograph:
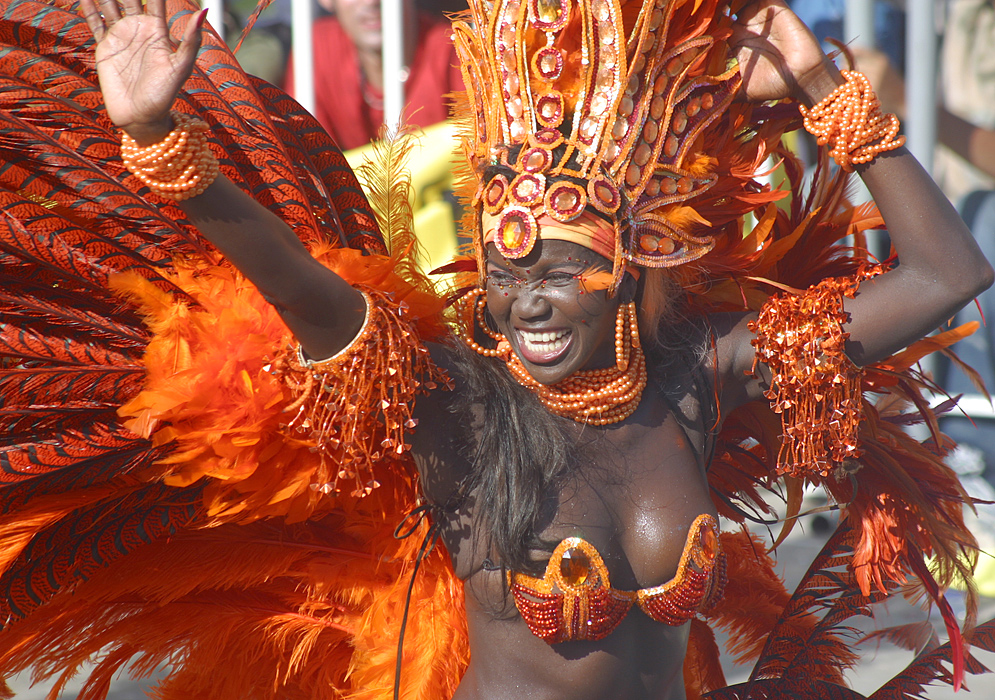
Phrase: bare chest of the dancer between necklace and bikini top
[{"left": 432, "top": 394, "right": 715, "bottom": 609}]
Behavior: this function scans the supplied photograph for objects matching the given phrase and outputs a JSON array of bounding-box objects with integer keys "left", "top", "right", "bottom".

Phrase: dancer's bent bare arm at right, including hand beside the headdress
[{"left": 727, "top": 0, "right": 993, "bottom": 402}]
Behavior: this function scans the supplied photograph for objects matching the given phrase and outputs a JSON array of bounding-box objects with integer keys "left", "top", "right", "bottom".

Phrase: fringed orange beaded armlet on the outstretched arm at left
[{"left": 279, "top": 289, "right": 449, "bottom": 497}]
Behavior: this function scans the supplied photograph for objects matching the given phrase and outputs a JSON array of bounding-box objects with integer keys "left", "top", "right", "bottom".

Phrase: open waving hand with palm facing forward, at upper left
[{"left": 80, "top": 0, "right": 206, "bottom": 145}]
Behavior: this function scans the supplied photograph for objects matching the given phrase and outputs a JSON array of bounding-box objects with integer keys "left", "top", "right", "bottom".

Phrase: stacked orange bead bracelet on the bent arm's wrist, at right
[{"left": 799, "top": 70, "right": 905, "bottom": 172}]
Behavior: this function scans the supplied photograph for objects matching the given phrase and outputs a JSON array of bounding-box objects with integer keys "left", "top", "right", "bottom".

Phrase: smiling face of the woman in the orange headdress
[{"left": 487, "top": 239, "right": 620, "bottom": 385}]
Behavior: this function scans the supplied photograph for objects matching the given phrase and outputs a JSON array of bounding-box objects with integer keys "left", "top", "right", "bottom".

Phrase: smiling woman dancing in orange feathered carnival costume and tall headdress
[{"left": 0, "top": 0, "right": 993, "bottom": 700}]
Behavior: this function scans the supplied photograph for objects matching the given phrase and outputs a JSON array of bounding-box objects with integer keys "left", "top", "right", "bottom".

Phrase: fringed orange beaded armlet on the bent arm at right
[{"left": 749, "top": 268, "right": 880, "bottom": 476}]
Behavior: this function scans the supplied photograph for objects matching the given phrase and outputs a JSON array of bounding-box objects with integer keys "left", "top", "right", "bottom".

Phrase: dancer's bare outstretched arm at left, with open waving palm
[{"left": 80, "top": 0, "right": 366, "bottom": 358}]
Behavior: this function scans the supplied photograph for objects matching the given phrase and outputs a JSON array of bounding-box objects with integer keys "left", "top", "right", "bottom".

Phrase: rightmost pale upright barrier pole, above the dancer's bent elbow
[{"left": 905, "top": 0, "right": 937, "bottom": 172}]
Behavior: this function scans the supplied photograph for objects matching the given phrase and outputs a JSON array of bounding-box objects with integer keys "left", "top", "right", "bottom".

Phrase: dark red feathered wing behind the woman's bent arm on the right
[{"left": 682, "top": 139, "right": 977, "bottom": 700}]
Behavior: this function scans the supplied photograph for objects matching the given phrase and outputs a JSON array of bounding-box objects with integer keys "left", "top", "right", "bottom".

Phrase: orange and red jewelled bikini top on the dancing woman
[{"left": 508, "top": 513, "right": 725, "bottom": 644}]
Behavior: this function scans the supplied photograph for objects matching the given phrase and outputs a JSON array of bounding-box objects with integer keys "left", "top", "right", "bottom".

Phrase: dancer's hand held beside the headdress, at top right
[{"left": 730, "top": 0, "right": 843, "bottom": 106}]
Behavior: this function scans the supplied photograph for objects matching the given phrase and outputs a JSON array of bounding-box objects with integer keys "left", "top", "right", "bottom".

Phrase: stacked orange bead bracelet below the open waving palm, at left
[{"left": 121, "top": 111, "right": 220, "bottom": 202}]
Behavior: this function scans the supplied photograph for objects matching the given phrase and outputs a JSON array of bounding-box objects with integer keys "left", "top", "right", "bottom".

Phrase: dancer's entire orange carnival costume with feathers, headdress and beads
[{"left": 0, "top": 0, "right": 995, "bottom": 700}]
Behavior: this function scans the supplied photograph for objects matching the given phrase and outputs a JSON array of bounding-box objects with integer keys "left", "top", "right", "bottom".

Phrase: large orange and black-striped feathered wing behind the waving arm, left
[{"left": 0, "top": 0, "right": 467, "bottom": 700}]
